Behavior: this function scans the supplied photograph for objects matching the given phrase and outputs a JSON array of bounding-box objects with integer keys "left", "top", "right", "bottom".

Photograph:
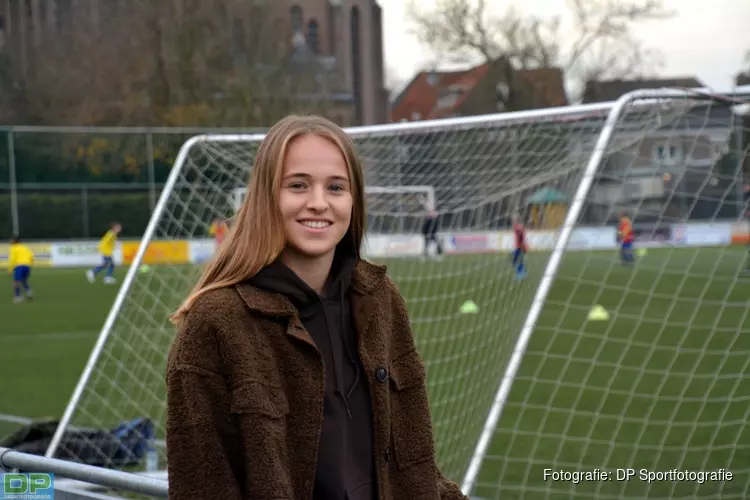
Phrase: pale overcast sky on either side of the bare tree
[{"left": 378, "top": 0, "right": 750, "bottom": 94}]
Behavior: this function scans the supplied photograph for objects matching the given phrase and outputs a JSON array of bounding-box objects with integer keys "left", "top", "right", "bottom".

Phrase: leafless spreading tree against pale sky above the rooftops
[{"left": 409, "top": 0, "right": 673, "bottom": 104}]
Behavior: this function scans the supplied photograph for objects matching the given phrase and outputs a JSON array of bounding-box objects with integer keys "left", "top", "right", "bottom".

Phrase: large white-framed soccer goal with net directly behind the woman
[{"left": 48, "top": 90, "right": 750, "bottom": 499}]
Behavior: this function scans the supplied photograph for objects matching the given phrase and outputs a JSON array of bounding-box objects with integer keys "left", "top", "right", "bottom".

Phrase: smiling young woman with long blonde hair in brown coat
[{"left": 167, "top": 116, "right": 467, "bottom": 500}]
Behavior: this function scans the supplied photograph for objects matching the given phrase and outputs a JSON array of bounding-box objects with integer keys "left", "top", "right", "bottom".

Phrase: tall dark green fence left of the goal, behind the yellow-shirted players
[{"left": 0, "top": 127, "right": 262, "bottom": 240}]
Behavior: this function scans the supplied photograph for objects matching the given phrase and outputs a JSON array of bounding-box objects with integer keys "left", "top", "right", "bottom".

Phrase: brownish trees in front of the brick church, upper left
[{"left": 15, "top": 0, "right": 333, "bottom": 127}]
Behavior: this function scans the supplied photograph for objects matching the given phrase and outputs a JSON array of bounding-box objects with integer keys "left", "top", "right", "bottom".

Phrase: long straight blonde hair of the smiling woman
[{"left": 169, "top": 115, "right": 367, "bottom": 324}]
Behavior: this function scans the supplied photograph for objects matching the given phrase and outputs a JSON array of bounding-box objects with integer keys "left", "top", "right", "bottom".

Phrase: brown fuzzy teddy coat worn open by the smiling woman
[{"left": 167, "top": 261, "right": 467, "bottom": 500}]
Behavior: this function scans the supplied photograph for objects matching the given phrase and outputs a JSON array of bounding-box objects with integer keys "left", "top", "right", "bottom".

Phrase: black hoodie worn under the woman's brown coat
[{"left": 249, "top": 249, "right": 377, "bottom": 500}]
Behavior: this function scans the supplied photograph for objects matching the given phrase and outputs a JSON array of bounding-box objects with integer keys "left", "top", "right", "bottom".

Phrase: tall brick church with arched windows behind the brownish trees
[{"left": 0, "top": 0, "right": 388, "bottom": 125}]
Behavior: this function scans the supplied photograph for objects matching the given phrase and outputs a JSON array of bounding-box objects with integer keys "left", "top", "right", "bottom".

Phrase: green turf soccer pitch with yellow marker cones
[{"left": 0, "top": 248, "right": 750, "bottom": 499}]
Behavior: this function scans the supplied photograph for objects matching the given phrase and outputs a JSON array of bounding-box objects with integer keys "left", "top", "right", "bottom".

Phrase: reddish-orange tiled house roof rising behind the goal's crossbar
[{"left": 391, "top": 63, "right": 567, "bottom": 121}]
